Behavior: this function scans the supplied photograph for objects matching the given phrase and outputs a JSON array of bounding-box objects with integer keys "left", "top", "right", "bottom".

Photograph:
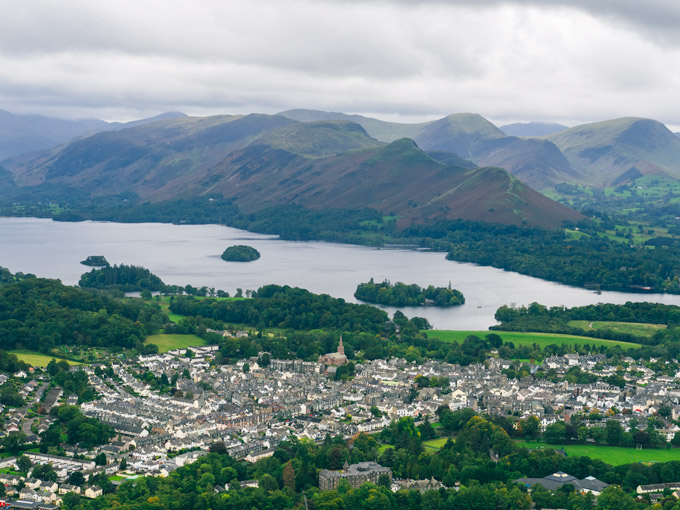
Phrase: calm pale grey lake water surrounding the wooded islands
[{"left": 0, "top": 218, "right": 680, "bottom": 330}]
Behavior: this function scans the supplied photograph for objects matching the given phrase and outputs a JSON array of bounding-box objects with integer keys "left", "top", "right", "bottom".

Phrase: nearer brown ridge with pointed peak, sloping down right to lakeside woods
[{"left": 205, "top": 139, "right": 581, "bottom": 227}]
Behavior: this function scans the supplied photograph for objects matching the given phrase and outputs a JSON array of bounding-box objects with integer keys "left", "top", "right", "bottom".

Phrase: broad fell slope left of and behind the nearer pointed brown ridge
[{"left": 7, "top": 115, "right": 293, "bottom": 198}]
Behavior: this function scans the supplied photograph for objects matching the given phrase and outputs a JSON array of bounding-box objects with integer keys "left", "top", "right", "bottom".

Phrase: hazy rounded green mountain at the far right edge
[{"left": 545, "top": 117, "right": 680, "bottom": 187}]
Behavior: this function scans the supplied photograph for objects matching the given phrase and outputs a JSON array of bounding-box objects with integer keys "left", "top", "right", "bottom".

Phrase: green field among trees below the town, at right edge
[{"left": 516, "top": 441, "right": 680, "bottom": 466}]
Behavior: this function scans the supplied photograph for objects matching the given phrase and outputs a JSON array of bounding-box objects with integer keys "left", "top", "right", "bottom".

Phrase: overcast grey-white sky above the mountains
[{"left": 0, "top": 0, "right": 680, "bottom": 131}]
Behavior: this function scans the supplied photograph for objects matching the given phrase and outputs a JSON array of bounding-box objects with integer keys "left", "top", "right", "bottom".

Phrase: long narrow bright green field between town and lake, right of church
[{"left": 425, "top": 329, "right": 640, "bottom": 349}]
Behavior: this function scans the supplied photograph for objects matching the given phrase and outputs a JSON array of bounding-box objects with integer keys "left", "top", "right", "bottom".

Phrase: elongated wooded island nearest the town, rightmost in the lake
[{"left": 354, "top": 278, "right": 465, "bottom": 306}]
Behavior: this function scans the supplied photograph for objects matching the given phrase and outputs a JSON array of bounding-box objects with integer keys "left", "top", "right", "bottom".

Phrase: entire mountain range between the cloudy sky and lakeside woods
[{"left": 0, "top": 110, "right": 680, "bottom": 231}]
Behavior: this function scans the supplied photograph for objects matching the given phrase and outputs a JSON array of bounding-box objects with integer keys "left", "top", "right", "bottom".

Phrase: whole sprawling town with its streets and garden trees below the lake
[{"left": 0, "top": 338, "right": 680, "bottom": 508}]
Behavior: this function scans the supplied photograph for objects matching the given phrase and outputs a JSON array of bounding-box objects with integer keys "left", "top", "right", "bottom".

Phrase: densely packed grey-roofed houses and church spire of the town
[{"left": 6, "top": 344, "right": 680, "bottom": 504}]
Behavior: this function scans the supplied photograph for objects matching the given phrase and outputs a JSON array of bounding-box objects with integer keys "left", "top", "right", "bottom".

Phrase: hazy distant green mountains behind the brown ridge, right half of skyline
[{"left": 281, "top": 110, "right": 680, "bottom": 190}]
